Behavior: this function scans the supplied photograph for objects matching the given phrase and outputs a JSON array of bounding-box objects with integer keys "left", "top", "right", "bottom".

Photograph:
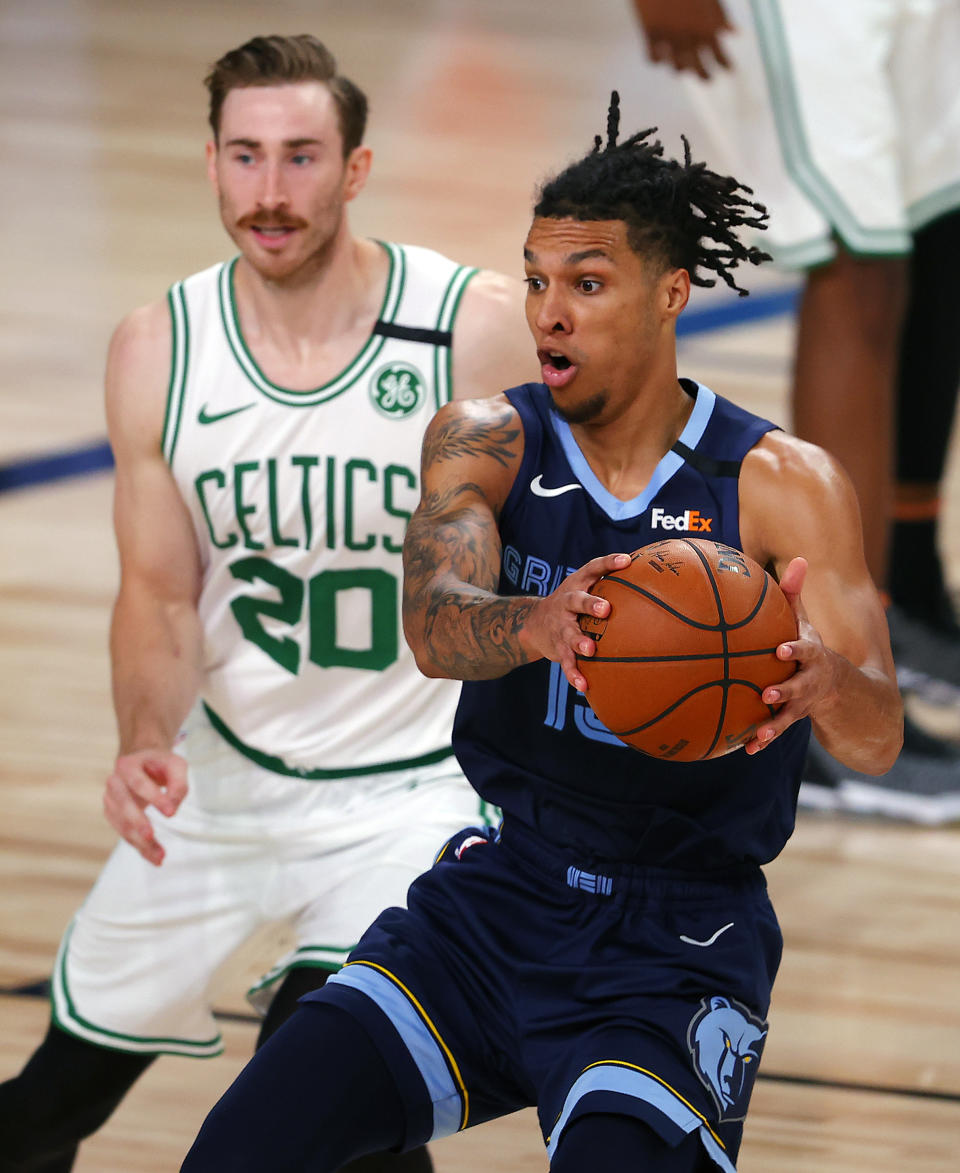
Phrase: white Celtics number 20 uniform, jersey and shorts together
[{"left": 53, "top": 244, "right": 495, "bottom": 1055}]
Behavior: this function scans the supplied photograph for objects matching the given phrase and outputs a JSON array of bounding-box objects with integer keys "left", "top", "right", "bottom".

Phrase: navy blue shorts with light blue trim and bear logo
[{"left": 303, "top": 825, "right": 782, "bottom": 1171}]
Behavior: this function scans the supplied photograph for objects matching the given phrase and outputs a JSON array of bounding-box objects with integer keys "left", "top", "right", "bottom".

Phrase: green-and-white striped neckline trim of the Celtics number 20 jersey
[{"left": 218, "top": 240, "right": 406, "bottom": 407}]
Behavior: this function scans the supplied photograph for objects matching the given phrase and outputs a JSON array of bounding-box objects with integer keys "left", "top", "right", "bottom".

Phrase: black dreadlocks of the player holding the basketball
[{"left": 534, "top": 90, "right": 771, "bottom": 297}]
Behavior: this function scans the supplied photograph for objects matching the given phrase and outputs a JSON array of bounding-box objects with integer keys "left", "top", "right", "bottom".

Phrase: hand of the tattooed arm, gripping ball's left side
[{"left": 523, "top": 554, "right": 631, "bottom": 692}]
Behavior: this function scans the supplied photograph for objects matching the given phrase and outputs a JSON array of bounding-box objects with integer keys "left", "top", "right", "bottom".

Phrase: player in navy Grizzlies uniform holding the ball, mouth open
[{"left": 183, "top": 100, "right": 902, "bottom": 1173}]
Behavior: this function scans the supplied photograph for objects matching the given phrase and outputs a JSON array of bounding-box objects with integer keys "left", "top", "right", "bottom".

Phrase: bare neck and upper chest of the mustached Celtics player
[{"left": 227, "top": 232, "right": 390, "bottom": 388}]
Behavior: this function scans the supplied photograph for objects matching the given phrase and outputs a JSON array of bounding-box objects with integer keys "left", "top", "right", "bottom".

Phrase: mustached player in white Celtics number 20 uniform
[{"left": 0, "top": 36, "right": 538, "bottom": 1173}]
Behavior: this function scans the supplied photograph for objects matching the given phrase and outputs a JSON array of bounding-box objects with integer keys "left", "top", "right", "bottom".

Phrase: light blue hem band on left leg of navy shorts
[{"left": 326, "top": 964, "right": 464, "bottom": 1140}]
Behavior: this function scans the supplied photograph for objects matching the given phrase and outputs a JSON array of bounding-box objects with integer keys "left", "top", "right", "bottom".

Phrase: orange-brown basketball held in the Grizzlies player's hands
[{"left": 577, "top": 537, "right": 797, "bottom": 761}]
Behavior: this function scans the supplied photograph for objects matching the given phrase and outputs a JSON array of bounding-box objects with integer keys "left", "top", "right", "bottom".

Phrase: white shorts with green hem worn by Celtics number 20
[{"left": 52, "top": 714, "right": 498, "bottom": 1056}]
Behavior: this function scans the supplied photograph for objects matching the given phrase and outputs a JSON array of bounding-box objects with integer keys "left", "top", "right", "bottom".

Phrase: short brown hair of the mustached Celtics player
[{"left": 203, "top": 33, "right": 367, "bottom": 158}]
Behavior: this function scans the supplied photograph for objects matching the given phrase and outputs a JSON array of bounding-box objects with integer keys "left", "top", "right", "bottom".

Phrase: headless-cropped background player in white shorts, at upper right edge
[{"left": 633, "top": 0, "right": 960, "bottom": 821}]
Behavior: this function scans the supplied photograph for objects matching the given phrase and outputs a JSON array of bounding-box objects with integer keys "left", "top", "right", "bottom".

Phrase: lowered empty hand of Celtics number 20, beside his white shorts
[{"left": 103, "top": 750, "right": 187, "bottom": 867}]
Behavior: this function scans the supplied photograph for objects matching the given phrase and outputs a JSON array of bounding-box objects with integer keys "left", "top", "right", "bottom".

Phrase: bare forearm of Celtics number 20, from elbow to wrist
[{"left": 110, "top": 590, "right": 203, "bottom": 754}]
